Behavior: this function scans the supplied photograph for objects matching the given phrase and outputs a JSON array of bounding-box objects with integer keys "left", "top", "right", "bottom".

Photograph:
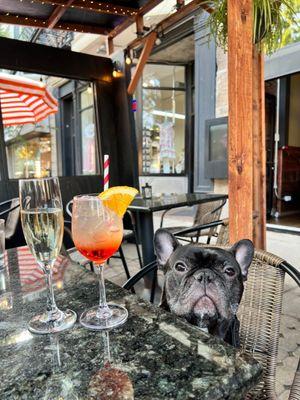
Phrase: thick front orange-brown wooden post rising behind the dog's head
[{"left": 227, "top": 0, "right": 253, "bottom": 243}]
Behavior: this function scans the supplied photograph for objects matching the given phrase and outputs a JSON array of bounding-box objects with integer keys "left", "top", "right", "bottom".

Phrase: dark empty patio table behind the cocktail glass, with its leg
[{"left": 128, "top": 193, "right": 228, "bottom": 265}]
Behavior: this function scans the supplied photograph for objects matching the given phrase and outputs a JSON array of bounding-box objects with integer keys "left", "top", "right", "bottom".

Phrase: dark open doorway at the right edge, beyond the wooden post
[{"left": 266, "top": 73, "right": 300, "bottom": 232}]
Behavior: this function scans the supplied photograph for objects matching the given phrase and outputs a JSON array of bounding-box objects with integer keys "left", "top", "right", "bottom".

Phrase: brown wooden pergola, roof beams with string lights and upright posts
[{"left": 0, "top": 0, "right": 266, "bottom": 249}]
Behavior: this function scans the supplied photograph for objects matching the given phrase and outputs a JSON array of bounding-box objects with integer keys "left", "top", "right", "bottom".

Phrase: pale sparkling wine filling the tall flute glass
[{"left": 21, "top": 208, "right": 64, "bottom": 264}]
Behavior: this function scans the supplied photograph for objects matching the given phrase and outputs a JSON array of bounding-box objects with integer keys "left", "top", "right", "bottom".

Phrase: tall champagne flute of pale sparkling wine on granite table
[{"left": 19, "top": 178, "right": 77, "bottom": 334}]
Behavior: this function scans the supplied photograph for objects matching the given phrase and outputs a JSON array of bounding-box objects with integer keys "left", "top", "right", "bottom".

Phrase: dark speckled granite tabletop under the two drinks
[{"left": 0, "top": 248, "right": 261, "bottom": 400}]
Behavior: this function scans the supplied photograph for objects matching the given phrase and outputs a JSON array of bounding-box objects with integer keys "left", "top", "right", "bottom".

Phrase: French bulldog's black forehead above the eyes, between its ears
[{"left": 167, "top": 245, "right": 239, "bottom": 268}]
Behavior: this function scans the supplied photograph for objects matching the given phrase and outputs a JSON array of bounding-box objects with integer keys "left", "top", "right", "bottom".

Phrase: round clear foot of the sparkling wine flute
[{"left": 28, "top": 310, "right": 77, "bottom": 335}]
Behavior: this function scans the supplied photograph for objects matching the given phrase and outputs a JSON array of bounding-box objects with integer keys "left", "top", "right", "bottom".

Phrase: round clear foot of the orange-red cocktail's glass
[{"left": 79, "top": 303, "right": 128, "bottom": 331}]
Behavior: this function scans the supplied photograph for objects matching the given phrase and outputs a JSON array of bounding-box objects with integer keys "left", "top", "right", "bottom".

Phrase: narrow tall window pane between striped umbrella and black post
[{"left": 80, "top": 87, "right": 96, "bottom": 175}]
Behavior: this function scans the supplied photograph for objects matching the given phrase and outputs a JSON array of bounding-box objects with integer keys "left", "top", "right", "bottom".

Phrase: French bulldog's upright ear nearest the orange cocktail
[{"left": 154, "top": 229, "right": 180, "bottom": 266}]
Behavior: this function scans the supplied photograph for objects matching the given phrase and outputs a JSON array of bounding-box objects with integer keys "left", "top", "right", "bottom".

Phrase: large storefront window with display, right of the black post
[{"left": 142, "top": 64, "right": 185, "bottom": 174}]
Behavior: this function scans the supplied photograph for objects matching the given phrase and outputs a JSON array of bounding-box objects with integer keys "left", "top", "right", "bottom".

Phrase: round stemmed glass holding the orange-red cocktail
[{"left": 72, "top": 195, "right": 128, "bottom": 330}]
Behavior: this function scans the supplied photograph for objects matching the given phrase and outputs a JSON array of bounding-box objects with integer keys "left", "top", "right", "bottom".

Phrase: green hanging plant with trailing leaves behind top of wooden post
[{"left": 206, "top": 0, "right": 296, "bottom": 54}]
